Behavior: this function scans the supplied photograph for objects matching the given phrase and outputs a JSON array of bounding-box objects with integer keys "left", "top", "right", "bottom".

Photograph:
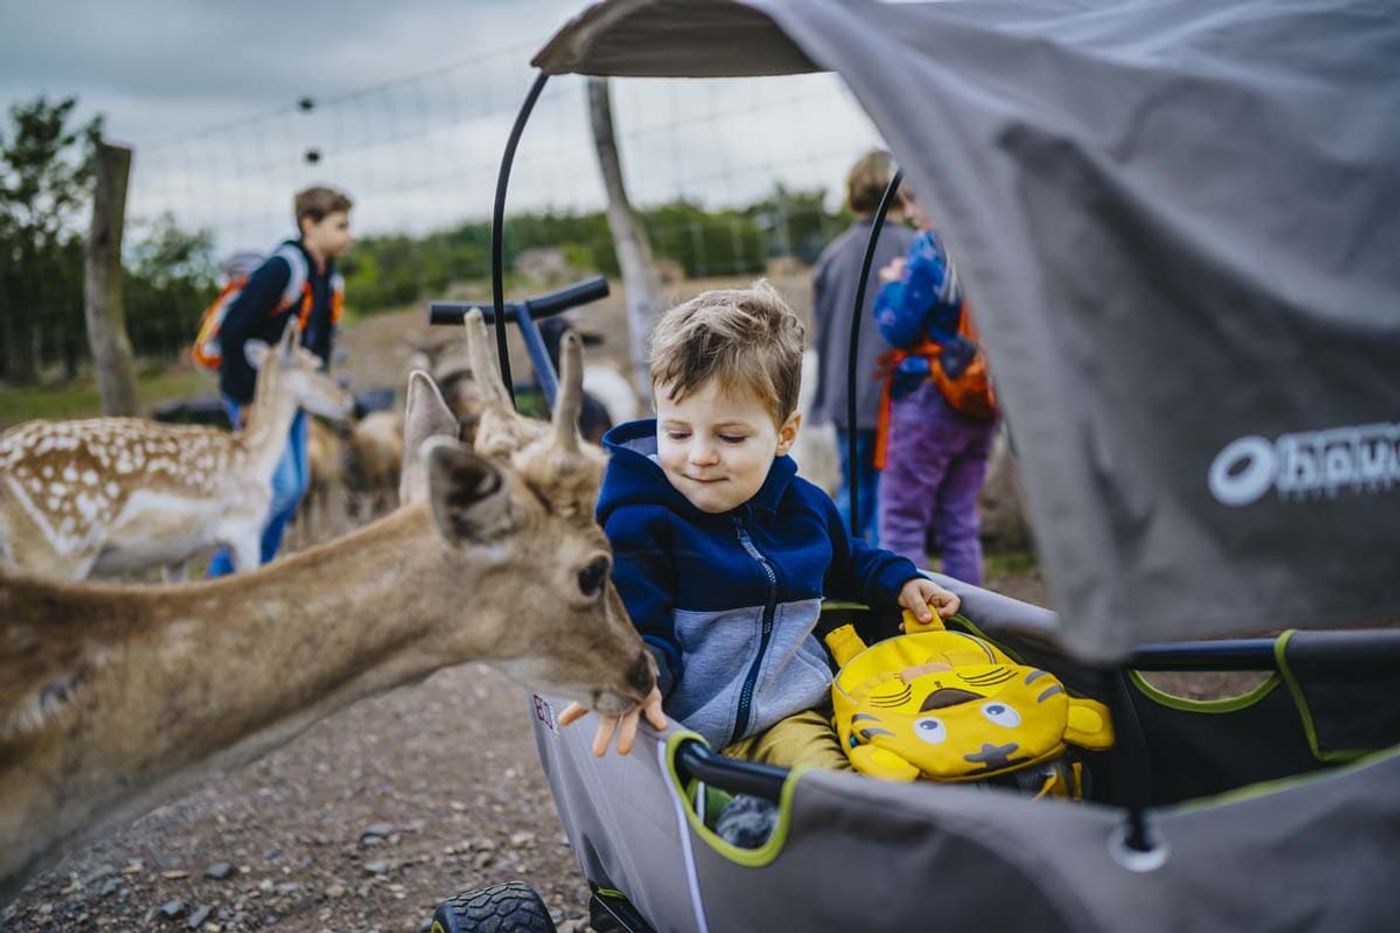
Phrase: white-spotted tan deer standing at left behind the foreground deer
[{"left": 0, "top": 326, "right": 353, "bottom": 580}]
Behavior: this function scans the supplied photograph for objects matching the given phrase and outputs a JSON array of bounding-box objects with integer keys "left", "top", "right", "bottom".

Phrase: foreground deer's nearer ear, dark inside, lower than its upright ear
[{"left": 424, "top": 443, "right": 515, "bottom": 546}]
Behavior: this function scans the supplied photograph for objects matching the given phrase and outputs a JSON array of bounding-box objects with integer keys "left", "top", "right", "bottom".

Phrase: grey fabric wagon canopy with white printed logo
[{"left": 535, "top": 0, "right": 1400, "bottom": 661}]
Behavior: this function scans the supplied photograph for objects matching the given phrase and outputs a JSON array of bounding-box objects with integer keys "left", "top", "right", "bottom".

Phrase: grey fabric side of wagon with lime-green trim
[{"left": 532, "top": 583, "right": 1400, "bottom": 932}]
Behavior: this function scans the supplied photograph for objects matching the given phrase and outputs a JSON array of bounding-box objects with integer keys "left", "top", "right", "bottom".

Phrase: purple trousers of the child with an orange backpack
[{"left": 879, "top": 382, "right": 997, "bottom": 584}]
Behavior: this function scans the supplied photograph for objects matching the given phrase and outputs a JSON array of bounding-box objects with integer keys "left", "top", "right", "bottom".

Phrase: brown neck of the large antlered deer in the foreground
[{"left": 0, "top": 506, "right": 504, "bottom": 902}]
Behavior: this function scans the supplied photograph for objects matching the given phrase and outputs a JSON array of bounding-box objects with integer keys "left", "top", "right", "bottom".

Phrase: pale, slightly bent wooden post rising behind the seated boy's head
[{"left": 588, "top": 77, "right": 661, "bottom": 389}]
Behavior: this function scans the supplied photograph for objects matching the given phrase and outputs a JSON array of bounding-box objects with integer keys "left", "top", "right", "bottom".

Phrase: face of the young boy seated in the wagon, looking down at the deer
[{"left": 657, "top": 380, "right": 802, "bottom": 514}]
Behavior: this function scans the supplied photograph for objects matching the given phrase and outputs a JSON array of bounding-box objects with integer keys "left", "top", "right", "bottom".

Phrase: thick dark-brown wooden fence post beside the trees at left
[{"left": 83, "top": 141, "right": 137, "bottom": 415}]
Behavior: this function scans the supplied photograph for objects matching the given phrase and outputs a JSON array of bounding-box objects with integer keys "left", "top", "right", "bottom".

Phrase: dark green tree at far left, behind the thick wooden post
[{"left": 0, "top": 97, "right": 102, "bottom": 382}]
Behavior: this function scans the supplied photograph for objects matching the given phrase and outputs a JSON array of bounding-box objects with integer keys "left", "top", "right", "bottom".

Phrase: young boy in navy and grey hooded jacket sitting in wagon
[{"left": 561, "top": 282, "right": 958, "bottom": 768}]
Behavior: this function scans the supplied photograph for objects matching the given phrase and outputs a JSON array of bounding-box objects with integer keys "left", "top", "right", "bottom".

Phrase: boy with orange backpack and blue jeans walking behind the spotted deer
[{"left": 193, "top": 188, "right": 351, "bottom": 577}]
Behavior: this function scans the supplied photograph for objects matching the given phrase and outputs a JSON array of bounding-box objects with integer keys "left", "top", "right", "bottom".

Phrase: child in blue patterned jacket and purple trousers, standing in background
[{"left": 875, "top": 210, "right": 997, "bottom": 584}]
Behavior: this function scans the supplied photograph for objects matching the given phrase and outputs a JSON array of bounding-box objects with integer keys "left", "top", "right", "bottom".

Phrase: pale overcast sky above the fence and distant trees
[{"left": 0, "top": 0, "right": 876, "bottom": 251}]
